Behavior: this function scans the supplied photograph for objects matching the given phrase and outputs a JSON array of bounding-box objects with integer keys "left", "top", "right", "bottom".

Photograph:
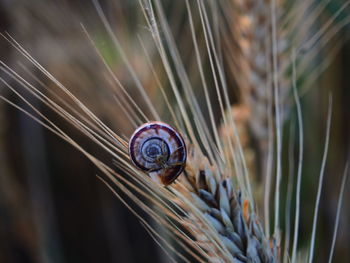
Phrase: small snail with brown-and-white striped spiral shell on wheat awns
[{"left": 129, "top": 121, "right": 187, "bottom": 185}]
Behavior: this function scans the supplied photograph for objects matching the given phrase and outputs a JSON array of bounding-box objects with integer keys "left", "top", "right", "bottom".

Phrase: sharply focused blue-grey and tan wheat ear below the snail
[{"left": 170, "top": 143, "right": 278, "bottom": 262}]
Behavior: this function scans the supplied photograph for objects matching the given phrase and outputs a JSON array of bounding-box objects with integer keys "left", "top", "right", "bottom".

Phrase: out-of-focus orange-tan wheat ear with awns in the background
[{"left": 222, "top": 0, "right": 349, "bottom": 246}]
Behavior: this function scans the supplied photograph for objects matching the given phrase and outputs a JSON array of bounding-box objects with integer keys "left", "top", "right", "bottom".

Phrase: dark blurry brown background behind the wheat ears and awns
[{"left": 0, "top": 0, "right": 350, "bottom": 263}]
